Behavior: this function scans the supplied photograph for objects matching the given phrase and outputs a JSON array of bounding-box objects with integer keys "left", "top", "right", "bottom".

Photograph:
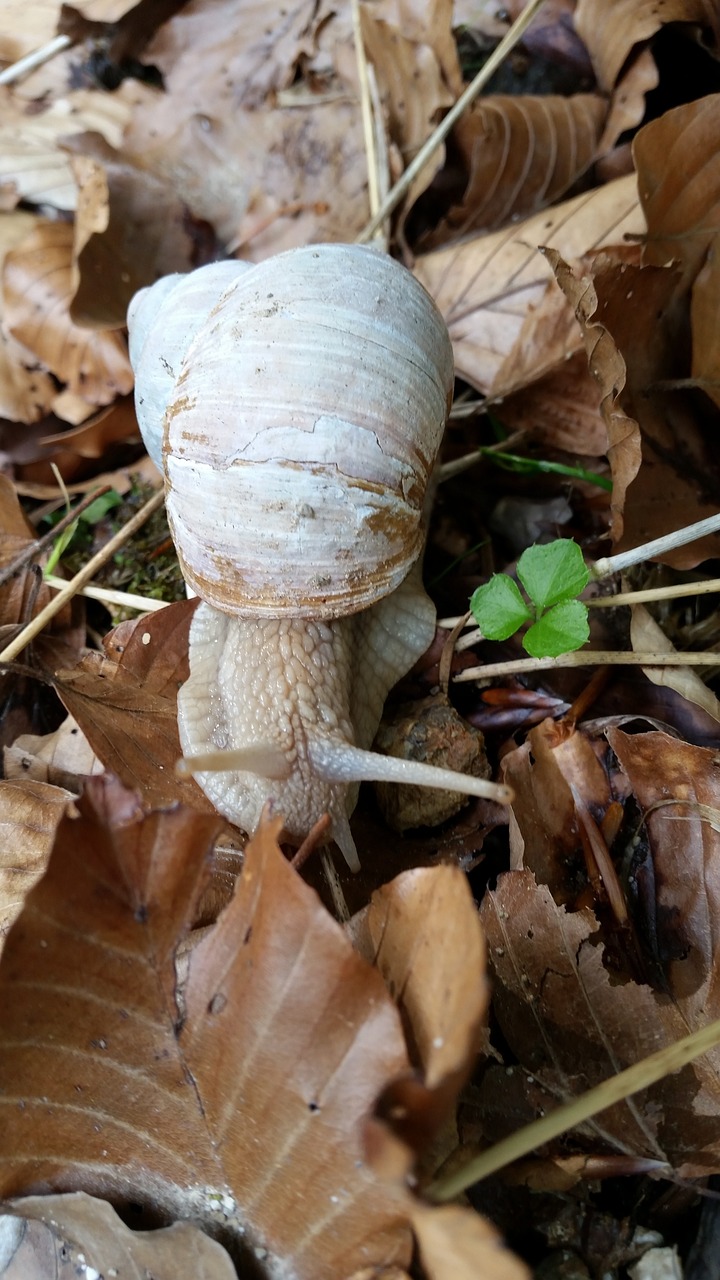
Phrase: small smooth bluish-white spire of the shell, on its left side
[{"left": 128, "top": 259, "right": 252, "bottom": 471}]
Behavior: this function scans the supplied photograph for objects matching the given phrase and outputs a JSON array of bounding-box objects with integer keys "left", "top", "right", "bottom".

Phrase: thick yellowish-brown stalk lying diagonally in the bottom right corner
[{"left": 425, "top": 1019, "right": 720, "bottom": 1201}]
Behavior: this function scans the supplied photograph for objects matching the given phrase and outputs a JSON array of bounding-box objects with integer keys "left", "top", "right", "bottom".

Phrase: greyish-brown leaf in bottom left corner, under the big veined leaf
[{"left": 0, "top": 1192, "right": 237, "bottom": 1280}]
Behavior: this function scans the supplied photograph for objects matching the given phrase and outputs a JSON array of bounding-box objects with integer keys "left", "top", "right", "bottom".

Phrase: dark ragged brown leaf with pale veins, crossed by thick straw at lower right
[{"left": 480, "top": 870, "right": 693, "bottom": 1161}]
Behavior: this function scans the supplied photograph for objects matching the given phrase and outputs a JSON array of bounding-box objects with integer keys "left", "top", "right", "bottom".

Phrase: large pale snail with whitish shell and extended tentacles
[{"left": 128, "top": 244, "right": 509, "bottom": 869}]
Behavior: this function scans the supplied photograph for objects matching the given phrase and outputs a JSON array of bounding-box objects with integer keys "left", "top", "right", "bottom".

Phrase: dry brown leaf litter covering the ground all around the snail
[{"left": 0, "top": 0, "right": 720, "bottom": 1280}]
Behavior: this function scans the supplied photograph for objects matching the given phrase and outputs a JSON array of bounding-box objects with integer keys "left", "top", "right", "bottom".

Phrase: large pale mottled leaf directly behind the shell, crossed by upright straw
[{"left": 119, "top": 0, "right": 460, "bottom": 260}]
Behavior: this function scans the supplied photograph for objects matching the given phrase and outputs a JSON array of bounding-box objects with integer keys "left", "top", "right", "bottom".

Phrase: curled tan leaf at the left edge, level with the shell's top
[{"left": 3, "top": 220, "right": 133, "bottom": 404}]
